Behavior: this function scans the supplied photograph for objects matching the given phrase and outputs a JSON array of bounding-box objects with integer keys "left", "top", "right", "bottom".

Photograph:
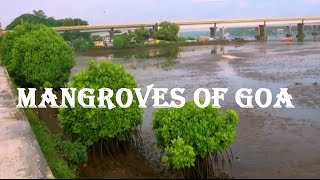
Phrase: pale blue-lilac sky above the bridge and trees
[{"left": 0, "top": 0, "right": 320, "bottom": 28}]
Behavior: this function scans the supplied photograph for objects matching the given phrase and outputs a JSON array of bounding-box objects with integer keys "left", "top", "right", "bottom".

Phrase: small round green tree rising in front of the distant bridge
[{"left": 155, "top": 21, "right": 180, "bottom": 41}]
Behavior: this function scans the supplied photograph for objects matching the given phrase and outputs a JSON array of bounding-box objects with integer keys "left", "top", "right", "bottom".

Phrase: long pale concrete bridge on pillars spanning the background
[{"left": 0, "top": 16, "right": 320, "bottom": 41}]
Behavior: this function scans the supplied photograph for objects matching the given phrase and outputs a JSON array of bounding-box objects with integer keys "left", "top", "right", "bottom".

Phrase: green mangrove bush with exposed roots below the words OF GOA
[{"left": 153, "top": 101, "right": 238, "bottom": 178}]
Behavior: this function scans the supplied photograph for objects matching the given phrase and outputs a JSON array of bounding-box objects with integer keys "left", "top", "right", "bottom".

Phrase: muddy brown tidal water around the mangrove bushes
[{"left": 67, "top": 42, "right": 320, "bottom": 178}]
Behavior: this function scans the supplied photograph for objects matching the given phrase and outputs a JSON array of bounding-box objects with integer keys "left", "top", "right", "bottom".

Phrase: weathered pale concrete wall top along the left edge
[{"left": 0, "top": 65, "right": 54, "bottom": 179}]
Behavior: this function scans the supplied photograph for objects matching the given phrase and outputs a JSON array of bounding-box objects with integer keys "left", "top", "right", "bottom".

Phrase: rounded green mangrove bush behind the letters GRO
[{"left": 59, "top": 62, "right": 142, "bottom": 146}]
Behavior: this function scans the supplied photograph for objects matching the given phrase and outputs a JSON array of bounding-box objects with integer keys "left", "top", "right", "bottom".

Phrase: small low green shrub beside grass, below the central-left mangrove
[{"left": 60, "top": 141, "right": 88, "bottom": 165}]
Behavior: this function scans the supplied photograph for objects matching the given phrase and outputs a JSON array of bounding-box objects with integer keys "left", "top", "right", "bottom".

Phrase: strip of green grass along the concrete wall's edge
[{"left": 24, "top": 109, "right": 78, "bottom": 179}]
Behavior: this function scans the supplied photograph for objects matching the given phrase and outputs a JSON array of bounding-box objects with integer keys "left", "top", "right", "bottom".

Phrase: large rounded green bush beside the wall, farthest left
[{"left": 8, "top": 25, "right": 74, "bottom": 88}]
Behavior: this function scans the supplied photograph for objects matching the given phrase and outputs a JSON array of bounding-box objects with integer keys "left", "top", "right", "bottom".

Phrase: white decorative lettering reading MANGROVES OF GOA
[{"left": 16, "top": 84, "right": 294, "bottom": 110}]
